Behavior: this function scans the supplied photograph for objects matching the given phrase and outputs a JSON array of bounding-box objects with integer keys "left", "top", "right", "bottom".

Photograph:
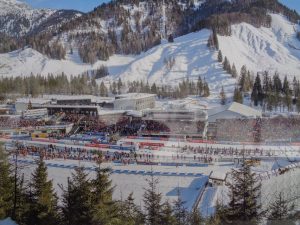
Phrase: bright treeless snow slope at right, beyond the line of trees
[{"left": 218, "top": 14, "right": 300, "bottom": 79}]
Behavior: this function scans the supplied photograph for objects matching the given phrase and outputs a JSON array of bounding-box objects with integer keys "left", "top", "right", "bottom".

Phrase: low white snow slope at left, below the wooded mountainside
[{"left": 0, "top": 48, "right": 132, "bottom": 76}]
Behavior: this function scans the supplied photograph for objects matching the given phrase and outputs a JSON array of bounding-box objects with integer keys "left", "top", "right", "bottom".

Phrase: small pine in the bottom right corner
[{"left": 267, "top": 192, "right": 296, "bottom": 225}]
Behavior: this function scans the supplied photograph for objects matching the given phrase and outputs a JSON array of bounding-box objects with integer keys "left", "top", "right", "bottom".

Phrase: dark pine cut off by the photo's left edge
[{"left": 0, "top": 145, "right": 14, "bottom": 220}]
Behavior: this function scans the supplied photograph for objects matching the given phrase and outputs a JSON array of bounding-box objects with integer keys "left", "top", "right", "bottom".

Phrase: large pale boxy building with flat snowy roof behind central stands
[{"left": 114, "top": 93, "right": 156, "bottom": 111}]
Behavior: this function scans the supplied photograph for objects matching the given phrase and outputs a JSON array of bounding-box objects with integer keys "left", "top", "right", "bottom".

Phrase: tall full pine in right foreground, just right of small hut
[{"left": 226, "top": 163, "right": 262, "bottom": 224}]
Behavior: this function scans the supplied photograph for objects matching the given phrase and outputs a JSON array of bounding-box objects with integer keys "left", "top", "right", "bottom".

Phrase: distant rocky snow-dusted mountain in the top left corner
[{"left": 0, "top": 0, "right": 82, "bottom": 37}]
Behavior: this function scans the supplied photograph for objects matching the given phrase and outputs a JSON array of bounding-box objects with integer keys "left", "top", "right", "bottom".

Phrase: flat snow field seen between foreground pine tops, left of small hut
[{"left": 19, "top": 158, "right": 208, "bottom": 210}]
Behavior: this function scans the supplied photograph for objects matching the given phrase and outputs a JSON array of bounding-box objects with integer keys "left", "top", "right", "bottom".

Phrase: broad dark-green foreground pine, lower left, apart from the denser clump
[{"left": 26, "top": 158, "right": 59, "bottom": 225}]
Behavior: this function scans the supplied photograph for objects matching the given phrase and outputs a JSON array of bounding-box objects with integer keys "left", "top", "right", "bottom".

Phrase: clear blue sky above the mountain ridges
[{"left": 23, "top": 0, "right": 300, "bottom": 14}]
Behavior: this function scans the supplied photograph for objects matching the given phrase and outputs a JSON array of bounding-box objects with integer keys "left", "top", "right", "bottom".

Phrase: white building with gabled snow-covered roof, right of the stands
[{"left": 208, "top": 102, "right": 262, "bottom": 123}]
